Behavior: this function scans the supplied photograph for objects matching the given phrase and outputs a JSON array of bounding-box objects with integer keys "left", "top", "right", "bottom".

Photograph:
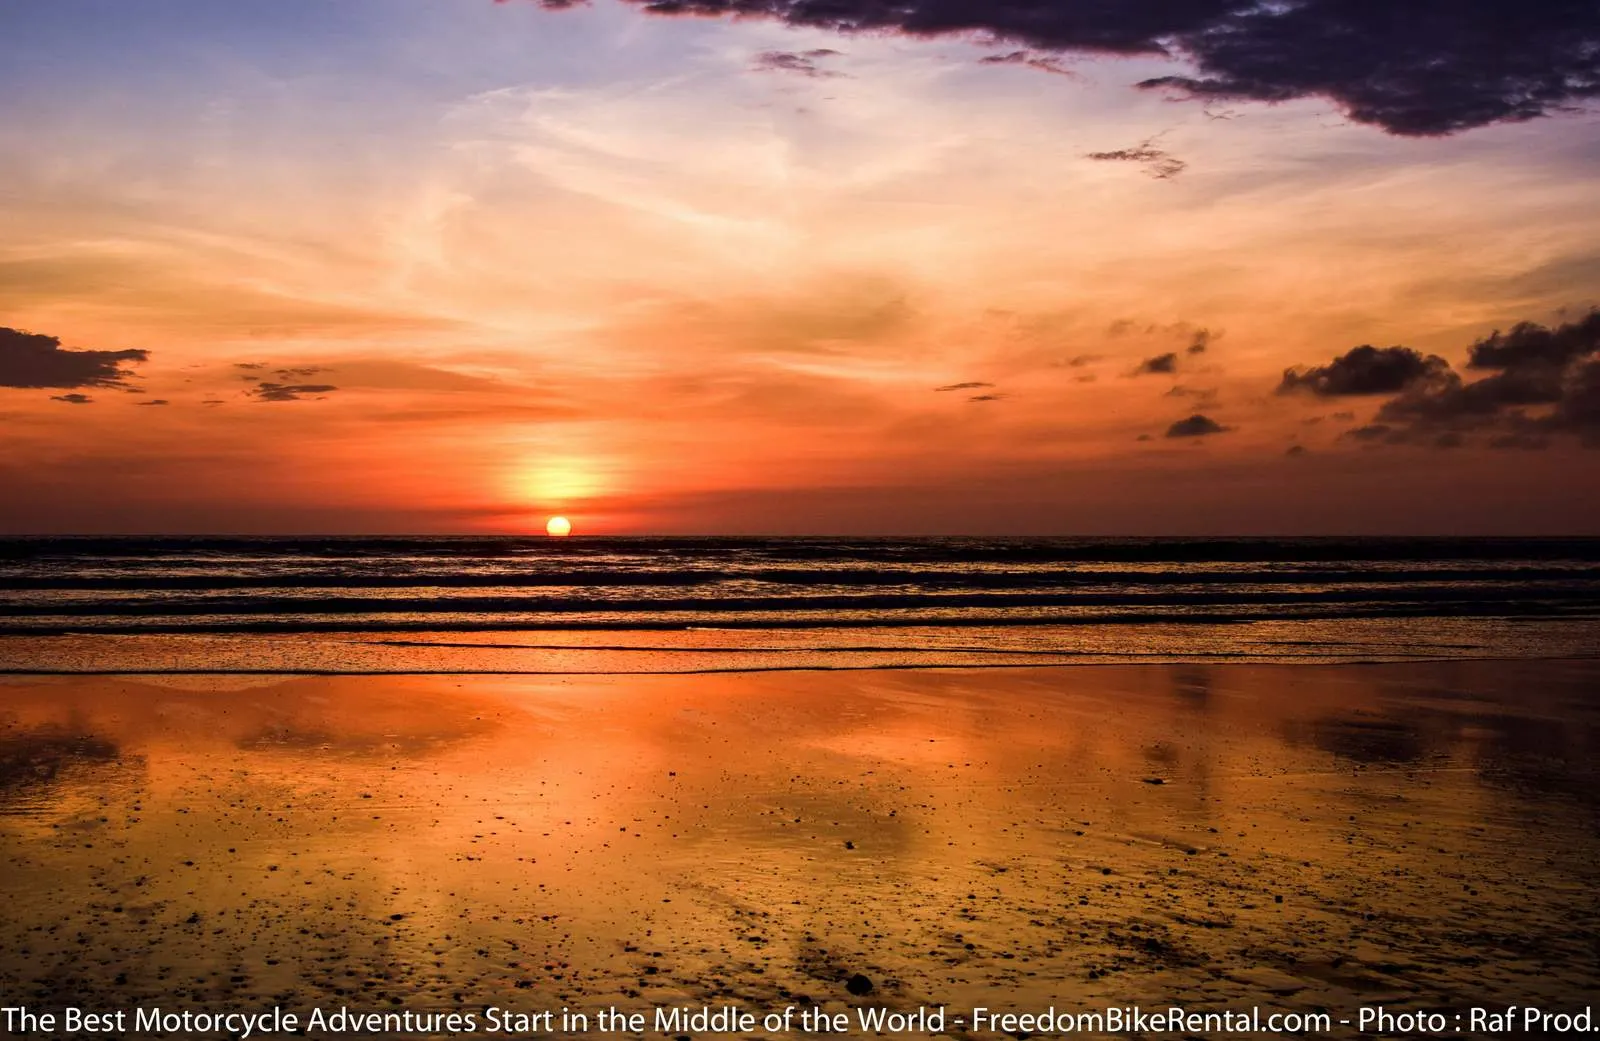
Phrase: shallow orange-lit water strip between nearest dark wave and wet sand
[{"left": 0, "top": 619, "right": 1600, "bottom": 676}]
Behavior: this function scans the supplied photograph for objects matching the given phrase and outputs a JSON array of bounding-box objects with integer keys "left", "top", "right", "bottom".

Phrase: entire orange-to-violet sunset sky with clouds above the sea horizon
[{"left": 0, "top": 0, "right": 1600, "bottom": 536}]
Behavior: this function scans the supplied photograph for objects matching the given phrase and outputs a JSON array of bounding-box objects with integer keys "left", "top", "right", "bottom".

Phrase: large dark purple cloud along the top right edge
[{"left": 536, "top": 0, "right": 1600, "bottom": 136}]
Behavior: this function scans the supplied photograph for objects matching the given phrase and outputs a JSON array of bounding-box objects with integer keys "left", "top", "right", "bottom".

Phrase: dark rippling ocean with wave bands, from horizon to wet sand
[{"left": 0, "top": 537, "right": 1600, "bottom": 672}]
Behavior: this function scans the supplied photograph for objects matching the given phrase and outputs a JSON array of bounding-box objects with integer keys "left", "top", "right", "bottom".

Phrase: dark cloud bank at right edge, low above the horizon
[{"left": 1278, "top": 312, "right": 1600, "bottom": 448}]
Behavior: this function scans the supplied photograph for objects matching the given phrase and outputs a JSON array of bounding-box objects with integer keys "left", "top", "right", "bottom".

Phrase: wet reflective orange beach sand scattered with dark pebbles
[{"left": 0, "top": 660, "right": 1600, "bottom": 1036}]
